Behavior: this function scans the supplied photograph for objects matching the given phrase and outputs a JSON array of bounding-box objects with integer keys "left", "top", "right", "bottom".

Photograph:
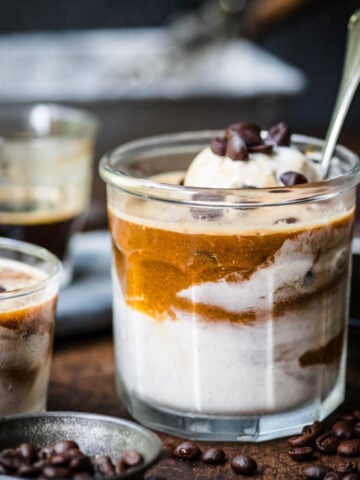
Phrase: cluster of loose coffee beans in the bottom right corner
[{"left": 288, "top": 410, "right": 360, "bottom": 480}]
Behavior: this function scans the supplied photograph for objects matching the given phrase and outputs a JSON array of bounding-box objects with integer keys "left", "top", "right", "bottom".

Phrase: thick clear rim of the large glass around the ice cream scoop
[{"left": 99, "top": 130, "right": 360, "bottom": 208}]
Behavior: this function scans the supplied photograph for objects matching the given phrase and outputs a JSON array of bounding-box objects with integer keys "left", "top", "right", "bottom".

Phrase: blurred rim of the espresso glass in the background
[{"left": 0, "top": 102, "right": 99, "bottom": 142}]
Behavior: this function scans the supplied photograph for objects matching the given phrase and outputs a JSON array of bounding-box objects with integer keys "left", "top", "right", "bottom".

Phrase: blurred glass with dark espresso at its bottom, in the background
[{"left": 0, "top": 104, "right": 97, "bottom": 284}]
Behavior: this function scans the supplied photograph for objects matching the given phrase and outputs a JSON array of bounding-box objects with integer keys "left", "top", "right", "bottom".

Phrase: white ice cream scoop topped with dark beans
[{"left": 184, "top": 122, "right": 320, "bottom": 188}]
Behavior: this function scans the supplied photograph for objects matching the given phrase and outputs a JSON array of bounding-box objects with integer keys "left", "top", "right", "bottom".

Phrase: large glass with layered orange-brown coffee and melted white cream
[{"left": 100, "top": 131, "right": 360, "bottom": 441}]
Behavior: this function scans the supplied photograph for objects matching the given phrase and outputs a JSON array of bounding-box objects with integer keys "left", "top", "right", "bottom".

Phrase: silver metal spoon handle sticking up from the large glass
[{"left": 321, "top": 10, "right": 360, "bottom": 178}]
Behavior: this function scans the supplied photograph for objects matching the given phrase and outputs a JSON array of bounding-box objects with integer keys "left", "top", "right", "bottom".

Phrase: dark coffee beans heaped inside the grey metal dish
[{"left": 0, "top": 440, "right": 143, "bottom": 480}]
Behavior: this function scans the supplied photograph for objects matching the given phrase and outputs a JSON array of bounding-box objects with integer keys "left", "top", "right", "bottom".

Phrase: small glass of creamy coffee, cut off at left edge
[{"left": 0, "top": 237, "right": 62, "bottom": 415}]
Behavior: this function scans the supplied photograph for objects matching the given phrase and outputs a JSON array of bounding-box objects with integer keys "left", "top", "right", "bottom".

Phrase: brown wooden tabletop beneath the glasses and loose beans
[{"left": 48, "top": 327, "right": 360, "bottom": 480}]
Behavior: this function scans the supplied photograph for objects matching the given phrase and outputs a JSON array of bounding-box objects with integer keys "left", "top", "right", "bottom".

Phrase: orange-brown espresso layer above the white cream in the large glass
[{"left": 110, "top": 213, "right": 353, "bottom": 322}]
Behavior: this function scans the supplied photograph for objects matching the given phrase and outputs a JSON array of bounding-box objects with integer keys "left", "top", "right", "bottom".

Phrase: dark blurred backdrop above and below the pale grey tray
[{"left": 0, "top": 0, "right": 360, "bottom": 224}]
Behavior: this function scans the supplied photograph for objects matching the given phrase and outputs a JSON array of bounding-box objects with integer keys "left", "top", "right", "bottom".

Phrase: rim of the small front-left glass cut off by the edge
[{"left": 0, "top": 237, "right": 63, "bottom": 302}]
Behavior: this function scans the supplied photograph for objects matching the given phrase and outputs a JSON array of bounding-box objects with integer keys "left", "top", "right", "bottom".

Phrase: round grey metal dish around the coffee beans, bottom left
[{"left": 0, "top": 412, "right": 161, "bottom": 480}]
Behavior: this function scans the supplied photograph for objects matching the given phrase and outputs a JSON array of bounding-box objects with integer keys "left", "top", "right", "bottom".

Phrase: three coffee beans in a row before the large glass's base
[{"left": 170, "top": 441, "right": 258, "bottom": 480}]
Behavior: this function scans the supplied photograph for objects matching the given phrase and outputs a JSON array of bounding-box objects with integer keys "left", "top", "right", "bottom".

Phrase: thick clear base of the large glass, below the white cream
[{"left": 118, "top": 382, "right": 344, "bottom": 442}]
